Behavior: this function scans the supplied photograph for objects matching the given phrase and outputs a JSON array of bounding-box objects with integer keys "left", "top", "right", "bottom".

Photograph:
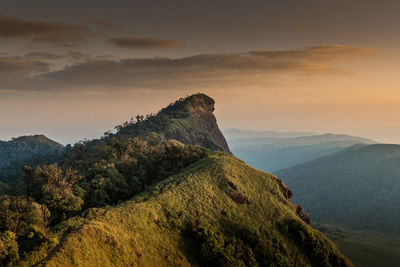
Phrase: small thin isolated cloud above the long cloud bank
[{"left": 109, "top": 37, "right": 185, "bottom": 49}]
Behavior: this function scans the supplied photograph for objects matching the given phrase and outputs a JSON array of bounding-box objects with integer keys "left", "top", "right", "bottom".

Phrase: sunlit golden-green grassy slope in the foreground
[{"left": 42, "top": 153, "right": 348, "bottom": 266}]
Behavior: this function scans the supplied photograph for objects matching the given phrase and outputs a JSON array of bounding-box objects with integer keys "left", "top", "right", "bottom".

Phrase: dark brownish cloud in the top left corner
[{"left": 0, "top": 16, "right": 90, "bottom": 43}]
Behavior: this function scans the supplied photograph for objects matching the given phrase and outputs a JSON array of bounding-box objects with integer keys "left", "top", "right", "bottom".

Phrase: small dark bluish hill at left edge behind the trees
[{"left": 0, "top": 135, "right": 64, "bottom": 167}]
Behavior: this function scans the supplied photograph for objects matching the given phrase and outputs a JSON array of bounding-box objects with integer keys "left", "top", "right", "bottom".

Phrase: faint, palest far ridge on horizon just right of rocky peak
[{"left": 223, "top": 128, "right": 315, "bottom": 140}]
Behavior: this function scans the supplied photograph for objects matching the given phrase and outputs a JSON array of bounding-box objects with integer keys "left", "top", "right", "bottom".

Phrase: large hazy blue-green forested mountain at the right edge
[{"left": 276, "top": 144, "right": 400, "bottom": 234}]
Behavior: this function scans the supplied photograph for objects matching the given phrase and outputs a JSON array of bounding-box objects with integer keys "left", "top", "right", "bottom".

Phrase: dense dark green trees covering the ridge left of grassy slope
[{"left": 0, "top": 138, "right": 209, "bottom": 266}]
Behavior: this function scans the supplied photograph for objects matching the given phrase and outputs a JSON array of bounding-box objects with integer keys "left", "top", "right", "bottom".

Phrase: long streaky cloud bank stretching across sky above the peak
[{"left": 0, "top": 45, "right": 376, "bottom": 90}]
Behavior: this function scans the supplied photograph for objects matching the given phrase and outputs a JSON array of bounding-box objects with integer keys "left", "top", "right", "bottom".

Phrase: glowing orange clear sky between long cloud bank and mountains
[{"left": 0, "top": 53, "right": 400, "bottom": 146}]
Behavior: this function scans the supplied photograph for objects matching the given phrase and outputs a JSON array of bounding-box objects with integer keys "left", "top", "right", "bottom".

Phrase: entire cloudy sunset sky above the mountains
[{"left": 0, "top": 0, "right": 400, "bottom": 144}]
